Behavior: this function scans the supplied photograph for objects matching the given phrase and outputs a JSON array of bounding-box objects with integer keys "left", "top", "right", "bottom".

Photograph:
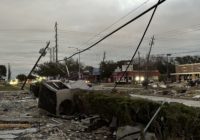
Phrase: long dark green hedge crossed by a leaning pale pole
[{"left": 74, "top": 92, "right": 200, "bottom": 139}]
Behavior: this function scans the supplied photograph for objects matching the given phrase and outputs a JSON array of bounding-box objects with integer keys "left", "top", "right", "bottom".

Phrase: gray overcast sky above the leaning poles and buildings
[{"left": 0, "top": 0, "right": 200, "bottom": 77}]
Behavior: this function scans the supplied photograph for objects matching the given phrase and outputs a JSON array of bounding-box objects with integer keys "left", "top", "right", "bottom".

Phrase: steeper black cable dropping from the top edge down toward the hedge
[{"left": 113, "top": 0, "right": 160, "bottom": 89}]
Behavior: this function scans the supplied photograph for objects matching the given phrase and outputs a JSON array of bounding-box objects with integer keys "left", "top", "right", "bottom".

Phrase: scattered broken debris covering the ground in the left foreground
[{"left": 0, "top": 91, "right": 113, "bottom": 140}]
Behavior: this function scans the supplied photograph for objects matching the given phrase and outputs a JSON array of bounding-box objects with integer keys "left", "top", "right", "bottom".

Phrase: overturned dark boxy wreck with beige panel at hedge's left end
[{"left": 38, "top": 80, "right": 74, "bottom": 115}]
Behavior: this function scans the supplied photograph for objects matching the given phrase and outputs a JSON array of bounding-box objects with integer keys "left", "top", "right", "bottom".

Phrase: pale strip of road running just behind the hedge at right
[{"left": 130, "top": 94, "right": 200, "bottom": 107}]
